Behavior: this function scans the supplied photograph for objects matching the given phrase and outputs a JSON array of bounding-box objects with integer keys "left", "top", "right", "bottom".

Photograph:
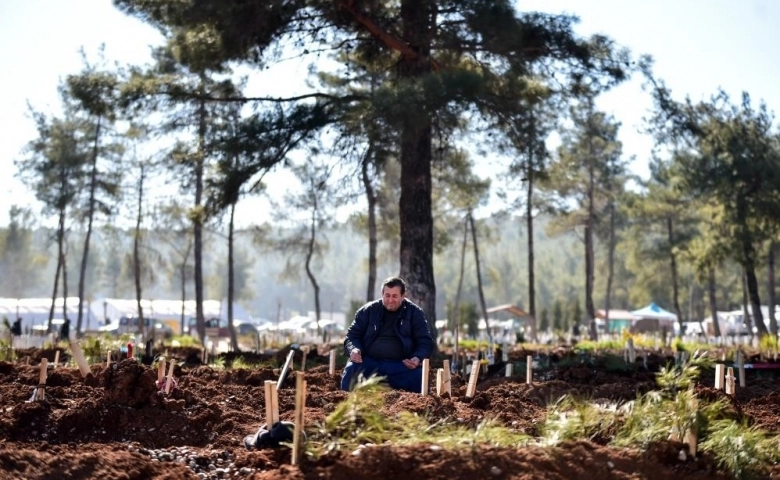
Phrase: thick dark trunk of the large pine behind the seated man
[{"left": 399, "top": 0, "right": 436, "bottom": 338}]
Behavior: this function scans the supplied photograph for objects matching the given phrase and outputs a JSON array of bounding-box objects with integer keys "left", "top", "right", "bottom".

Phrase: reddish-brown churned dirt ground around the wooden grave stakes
[{"left": 0, "top": 349, "right": 780, "bottom": 480}]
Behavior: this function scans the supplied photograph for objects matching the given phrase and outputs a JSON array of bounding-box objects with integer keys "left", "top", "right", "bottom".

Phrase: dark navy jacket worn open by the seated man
[{"left": 344, "top": 298, "right": 433, "bottom": 360}]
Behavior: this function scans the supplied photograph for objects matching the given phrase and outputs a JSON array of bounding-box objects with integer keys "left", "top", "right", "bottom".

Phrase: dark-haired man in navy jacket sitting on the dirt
[{"left": 341, "top": 277, "right": 433, "bottom": 393}]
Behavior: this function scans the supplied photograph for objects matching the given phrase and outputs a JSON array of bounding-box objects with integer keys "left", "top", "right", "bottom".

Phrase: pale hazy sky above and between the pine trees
[{"left": 0, "top": 0, "right": 780, "bottom": 225}]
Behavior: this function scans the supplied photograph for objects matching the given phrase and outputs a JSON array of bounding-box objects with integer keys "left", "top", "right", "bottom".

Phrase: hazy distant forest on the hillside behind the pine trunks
[{"left": 0, "top": 215, "right": 767, "bottom": 328}]
